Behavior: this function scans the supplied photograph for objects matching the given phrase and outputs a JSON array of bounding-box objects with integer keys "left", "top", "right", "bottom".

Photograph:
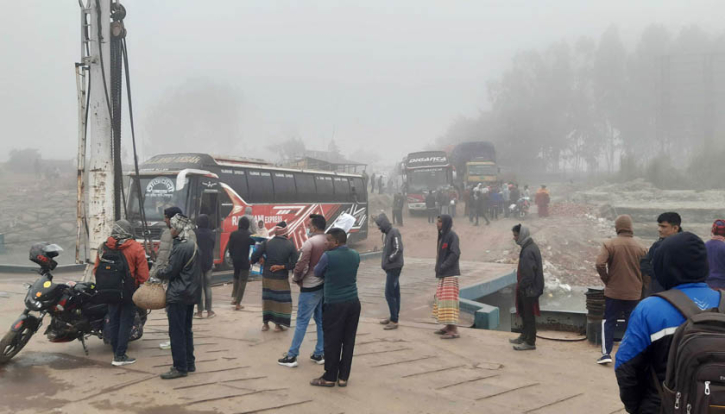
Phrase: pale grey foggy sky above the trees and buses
[{"left": 0, "top": 0, "right": 725, "bottom": 167}]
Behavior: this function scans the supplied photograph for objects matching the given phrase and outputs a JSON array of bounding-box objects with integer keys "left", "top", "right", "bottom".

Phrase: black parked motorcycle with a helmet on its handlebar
[{"left": 0, "top": 242, "right": 146, "bottom": 364}]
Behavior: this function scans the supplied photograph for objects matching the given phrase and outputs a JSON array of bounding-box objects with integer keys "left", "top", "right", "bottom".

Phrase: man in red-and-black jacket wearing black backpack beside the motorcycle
[{"left": 93, "top": 220, "right": 149, "bottom": 367}]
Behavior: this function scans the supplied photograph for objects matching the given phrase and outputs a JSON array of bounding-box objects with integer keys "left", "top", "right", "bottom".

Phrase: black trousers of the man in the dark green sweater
[{"left": 322, "top": 299, "right": 360, "bottom": 381}]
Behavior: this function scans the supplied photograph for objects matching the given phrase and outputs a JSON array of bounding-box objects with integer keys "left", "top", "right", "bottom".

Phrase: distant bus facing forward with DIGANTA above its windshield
[{"left": 403, "top": 151, "right": 453, "bottom": 213}]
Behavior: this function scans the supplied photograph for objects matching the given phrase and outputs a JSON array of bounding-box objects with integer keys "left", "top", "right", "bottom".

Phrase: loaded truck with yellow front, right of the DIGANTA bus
[{"left": 450, "top": 141, "right": 501, "bottom": 187}]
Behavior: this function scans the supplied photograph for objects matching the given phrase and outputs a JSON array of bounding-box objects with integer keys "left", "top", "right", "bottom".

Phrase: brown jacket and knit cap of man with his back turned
[{"left": 596, "top": 215, "right": 647, "bottom": 300}]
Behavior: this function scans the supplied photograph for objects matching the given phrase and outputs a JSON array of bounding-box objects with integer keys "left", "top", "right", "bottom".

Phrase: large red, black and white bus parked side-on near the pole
[{"left": 126, "top": 154, "right": 368, "bottom": 269}]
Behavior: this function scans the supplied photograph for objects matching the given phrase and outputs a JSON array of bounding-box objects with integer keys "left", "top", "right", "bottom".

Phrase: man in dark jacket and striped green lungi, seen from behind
[{"left": 251, "top": 221, "right": 299, "bottom": 332}]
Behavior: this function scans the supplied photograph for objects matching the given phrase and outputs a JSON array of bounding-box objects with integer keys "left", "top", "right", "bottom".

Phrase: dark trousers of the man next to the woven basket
[{"left": 166, "top": 303, "right": 196, "bottom": 372}]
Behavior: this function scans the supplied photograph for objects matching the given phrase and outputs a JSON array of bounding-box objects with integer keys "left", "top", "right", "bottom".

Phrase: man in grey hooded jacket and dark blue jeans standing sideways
[{"left": 375, "top": 213, "right": 403, "bottom": 331}]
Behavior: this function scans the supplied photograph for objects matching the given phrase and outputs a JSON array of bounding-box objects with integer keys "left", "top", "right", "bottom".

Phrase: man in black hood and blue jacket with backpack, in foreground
[{"left": 615, "top": 232, "right": 725, "bottom": 414}]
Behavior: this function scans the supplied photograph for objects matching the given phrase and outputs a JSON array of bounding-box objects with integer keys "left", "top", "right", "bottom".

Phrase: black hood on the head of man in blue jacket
[{"left": 652, "top": 232, "right": 710, "bottom": 290}]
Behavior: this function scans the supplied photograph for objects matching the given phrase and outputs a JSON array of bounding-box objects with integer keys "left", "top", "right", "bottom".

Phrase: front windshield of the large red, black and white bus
[{"left": 127, "top": 175, "right": 189, "bottom": 221}]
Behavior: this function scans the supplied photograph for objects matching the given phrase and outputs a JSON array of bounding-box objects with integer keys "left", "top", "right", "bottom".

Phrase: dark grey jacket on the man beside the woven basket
[{"left": 158, "top": 236, "right": 201, "bottom": 305}]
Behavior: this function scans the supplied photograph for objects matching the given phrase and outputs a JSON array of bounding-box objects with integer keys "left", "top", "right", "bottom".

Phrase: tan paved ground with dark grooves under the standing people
[{"left": 0, "top": 259, "right": 622, "bottom": 414}]
